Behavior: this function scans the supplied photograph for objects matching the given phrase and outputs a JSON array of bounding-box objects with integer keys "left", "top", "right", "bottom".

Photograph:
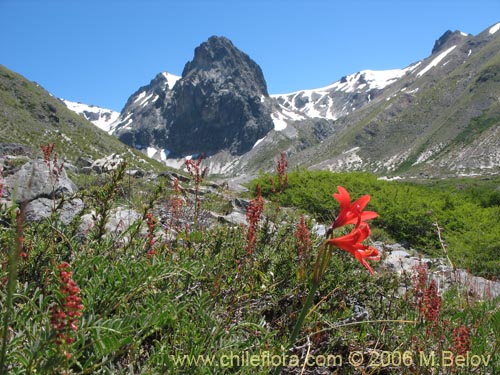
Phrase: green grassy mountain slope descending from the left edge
[{"left": 0, "top": 65, "right": 164, "bottom": 169}]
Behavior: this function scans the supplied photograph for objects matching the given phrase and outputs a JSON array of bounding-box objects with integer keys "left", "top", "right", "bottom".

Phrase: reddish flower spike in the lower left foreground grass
[{"left": 50, "top": 262, "right": 83, "bottom": 358}]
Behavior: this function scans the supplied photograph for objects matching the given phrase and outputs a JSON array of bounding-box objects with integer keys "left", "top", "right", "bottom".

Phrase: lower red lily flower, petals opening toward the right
[{"left": 328, "top": 222, "right": 380, "bottom": 275}]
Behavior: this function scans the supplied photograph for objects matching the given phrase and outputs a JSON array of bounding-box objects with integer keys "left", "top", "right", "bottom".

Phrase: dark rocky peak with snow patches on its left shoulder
[{"left": 114, "top": 36, "right": 274, "bottom": 157}]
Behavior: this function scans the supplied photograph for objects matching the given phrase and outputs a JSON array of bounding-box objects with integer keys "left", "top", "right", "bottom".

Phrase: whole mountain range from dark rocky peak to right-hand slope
[{"left": 107, "top": 25, "right": 500, "bottom": 176}]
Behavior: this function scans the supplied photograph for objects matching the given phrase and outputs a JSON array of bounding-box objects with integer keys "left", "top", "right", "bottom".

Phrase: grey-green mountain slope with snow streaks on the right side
[{"left": 293, "top": 24, "right": 500, "bottom": 176}]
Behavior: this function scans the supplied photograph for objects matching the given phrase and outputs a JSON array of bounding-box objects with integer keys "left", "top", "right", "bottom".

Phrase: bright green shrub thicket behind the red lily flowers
[{"left": 254, "top": 170, "right": 500, "bottom": 277}]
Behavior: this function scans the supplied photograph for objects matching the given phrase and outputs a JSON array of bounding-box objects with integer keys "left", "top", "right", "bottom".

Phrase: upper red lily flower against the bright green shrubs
[{"left": 331, "top": 186, "right": 378, "bottom": 230}]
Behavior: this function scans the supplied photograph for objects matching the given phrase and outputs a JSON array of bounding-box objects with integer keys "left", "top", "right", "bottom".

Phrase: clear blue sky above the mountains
[{"left": 0, "top": 0, "right": 500, "bottom": 111}]
